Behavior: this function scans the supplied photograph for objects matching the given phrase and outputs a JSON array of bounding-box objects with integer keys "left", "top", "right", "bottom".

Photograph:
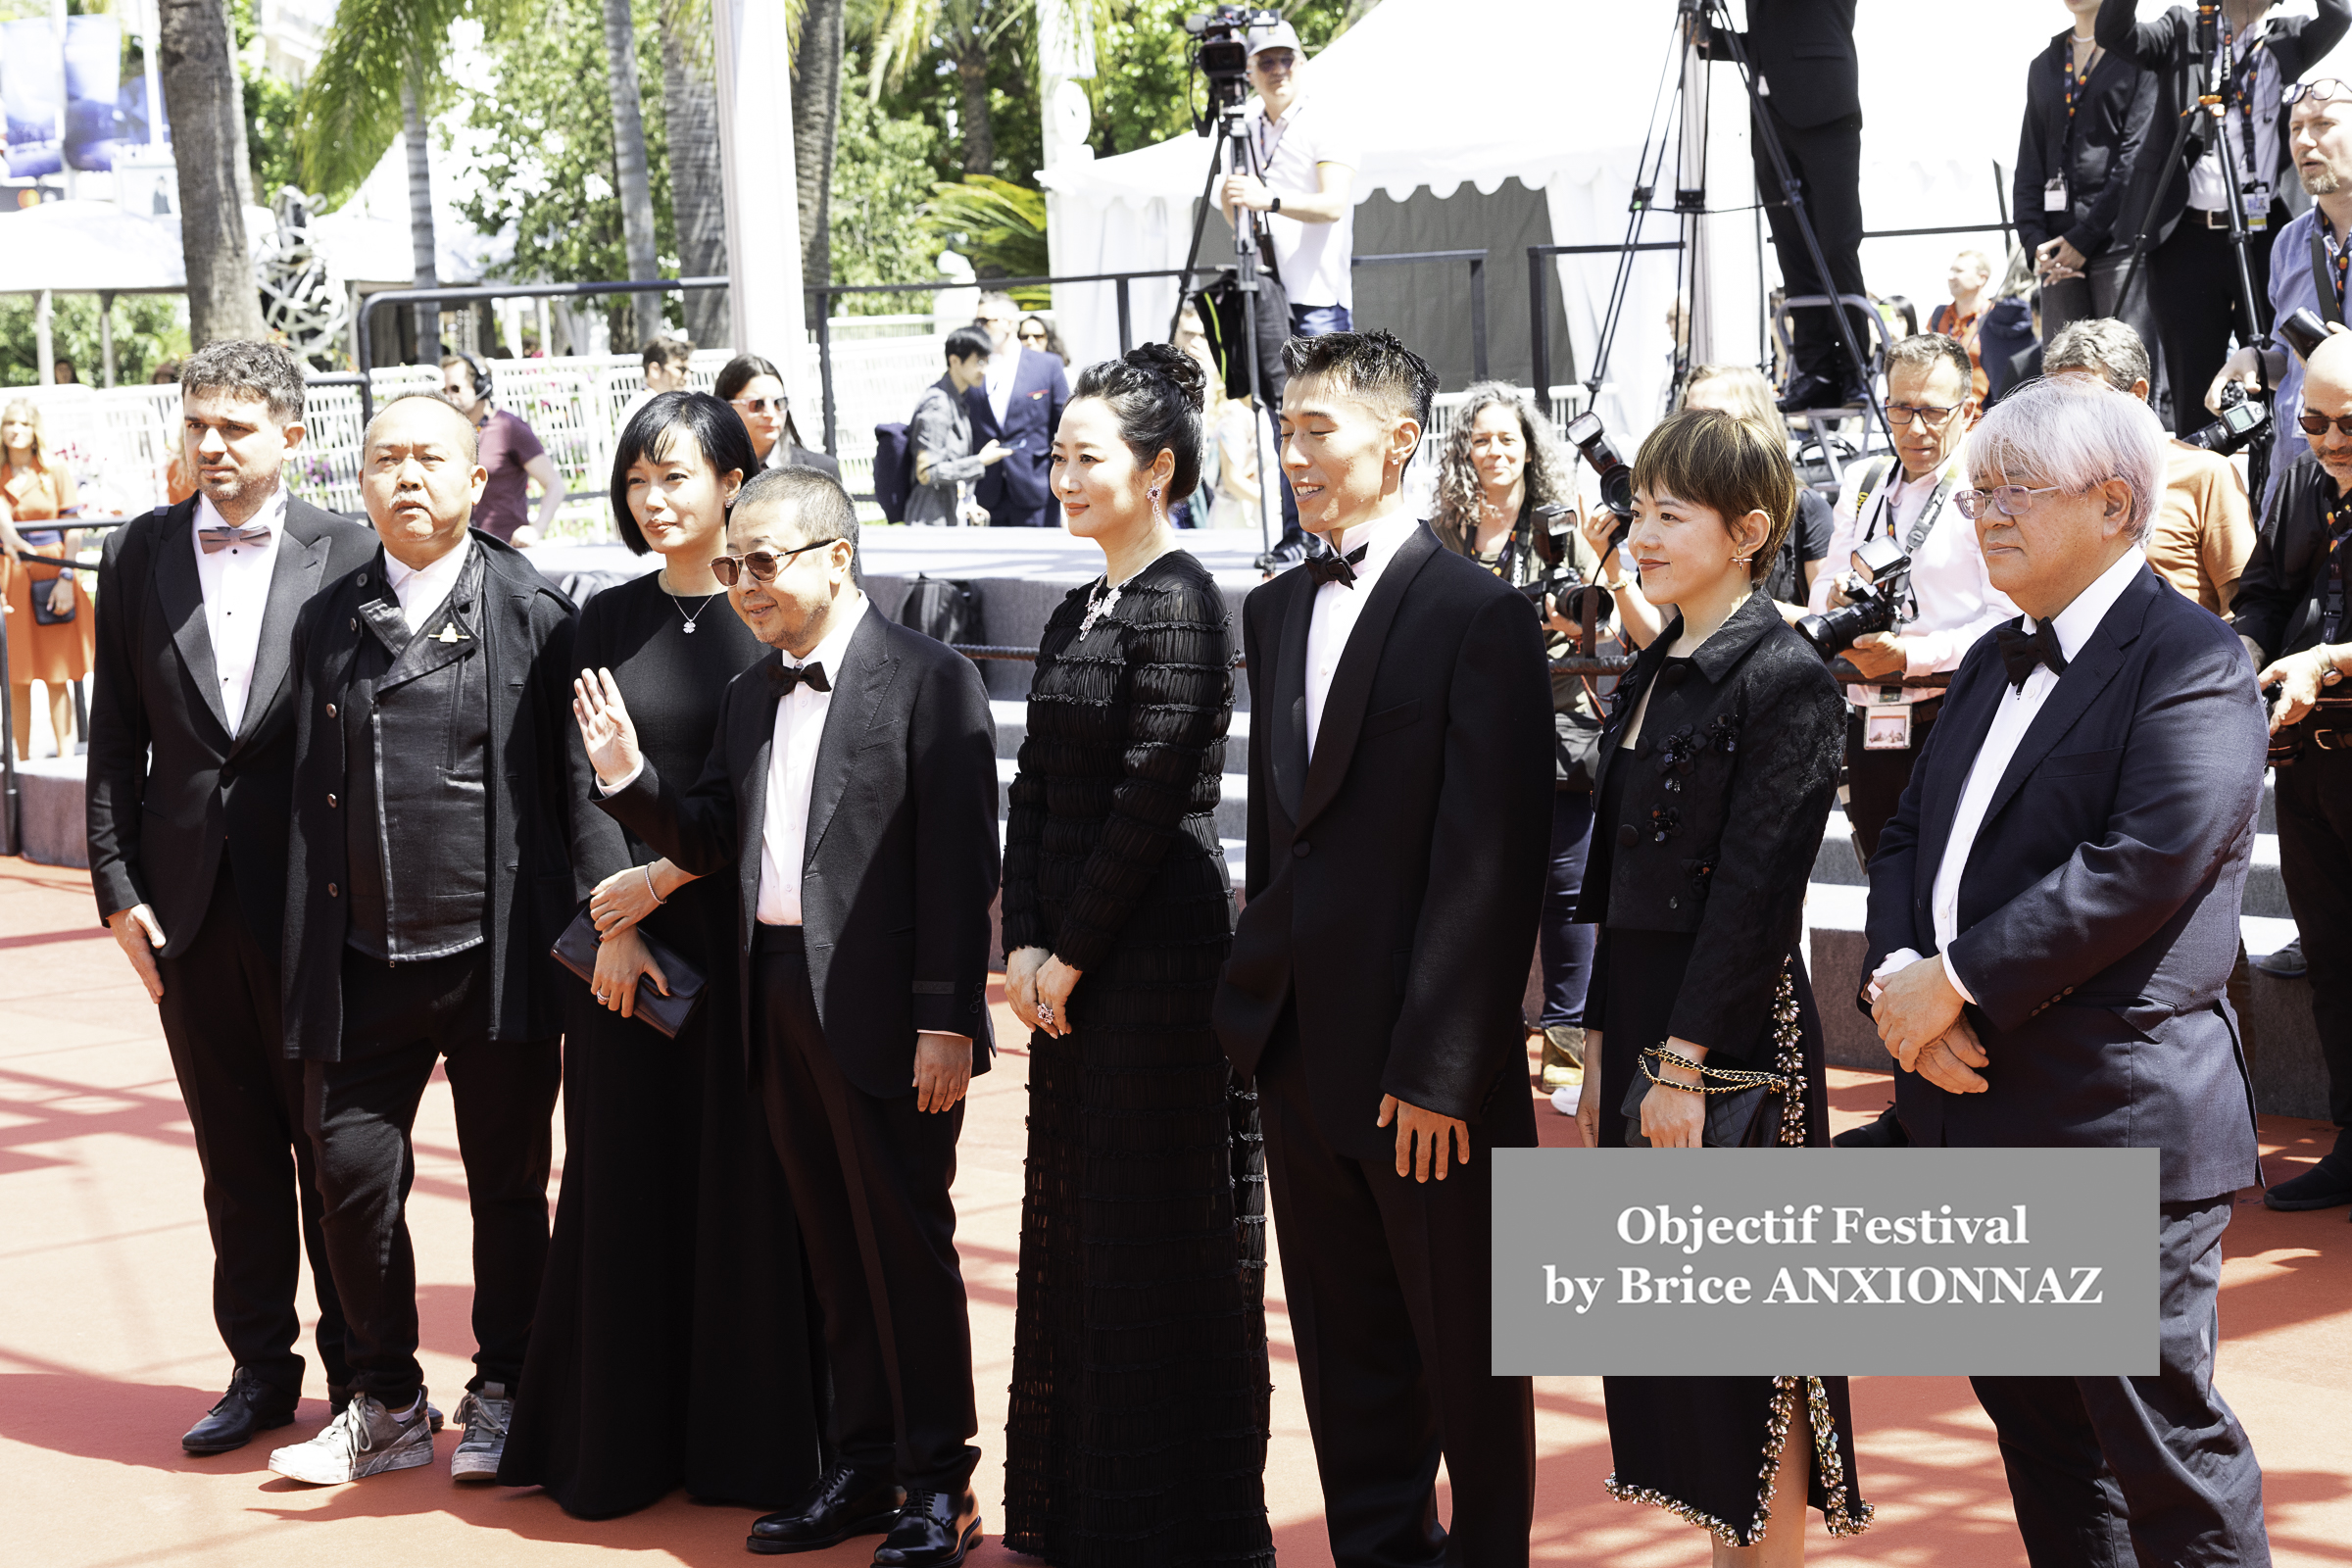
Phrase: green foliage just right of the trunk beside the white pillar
[{"left": 833, "top": 49, "right": 941, "bottom": 315}]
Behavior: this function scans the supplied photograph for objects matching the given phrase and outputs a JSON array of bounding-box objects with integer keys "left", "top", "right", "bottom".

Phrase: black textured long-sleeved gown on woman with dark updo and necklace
[{"left": 1004, "top": 550, "right": 1275, "bottom": 1568}]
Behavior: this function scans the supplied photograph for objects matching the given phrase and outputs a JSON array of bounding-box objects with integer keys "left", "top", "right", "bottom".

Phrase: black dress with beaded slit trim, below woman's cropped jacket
[{"left": 1588, "top": 753, "right": 1870, "bottom": 1546}]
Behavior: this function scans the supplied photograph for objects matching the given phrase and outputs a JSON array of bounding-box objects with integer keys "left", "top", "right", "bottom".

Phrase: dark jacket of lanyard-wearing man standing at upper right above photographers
[{"left": 2009, "top": 28, "right": 2154, "bottom": 256}]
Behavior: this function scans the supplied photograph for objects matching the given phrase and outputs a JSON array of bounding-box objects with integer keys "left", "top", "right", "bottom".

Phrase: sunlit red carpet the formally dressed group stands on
[{"left": 0, "top": 860, "right": 2352, "bottom": 1568}]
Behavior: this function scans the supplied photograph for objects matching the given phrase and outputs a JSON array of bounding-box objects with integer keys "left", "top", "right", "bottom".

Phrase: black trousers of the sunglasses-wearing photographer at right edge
[{"left": 2277, "top": 736, "right": 2352, "bottom": 1133}]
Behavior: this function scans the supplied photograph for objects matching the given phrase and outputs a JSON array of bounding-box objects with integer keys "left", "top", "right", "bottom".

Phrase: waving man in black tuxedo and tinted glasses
[{"left": 574, "top": 467, "right": 1002, "bottom": 1568}]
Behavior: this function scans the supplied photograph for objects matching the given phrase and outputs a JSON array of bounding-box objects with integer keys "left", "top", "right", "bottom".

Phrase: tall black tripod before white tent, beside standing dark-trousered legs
[{"left": 1586, "top": 0, "right": 1893, "bottom": 449}]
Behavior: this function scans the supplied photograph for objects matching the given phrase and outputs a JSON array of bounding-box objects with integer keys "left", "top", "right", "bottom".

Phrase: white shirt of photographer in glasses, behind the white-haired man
[{"left": 1811, "top": 454, "right": 2018, "bottom": 706}]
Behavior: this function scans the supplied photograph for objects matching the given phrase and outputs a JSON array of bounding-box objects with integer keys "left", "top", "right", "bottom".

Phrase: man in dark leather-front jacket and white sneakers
[{"left": 270, "top": 393, "right": 588, "bottom": 1484}]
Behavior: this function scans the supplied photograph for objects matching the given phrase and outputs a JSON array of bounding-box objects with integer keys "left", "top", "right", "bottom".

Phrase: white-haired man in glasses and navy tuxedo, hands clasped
[{"left": 1863, "top": 376, "right": 2270, "bottom": 1568}]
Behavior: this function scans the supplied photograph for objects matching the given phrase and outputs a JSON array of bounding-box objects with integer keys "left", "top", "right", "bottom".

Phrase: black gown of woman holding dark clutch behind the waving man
[{"left": 499, "top": 573, "right": 823, "bottom": 1519}]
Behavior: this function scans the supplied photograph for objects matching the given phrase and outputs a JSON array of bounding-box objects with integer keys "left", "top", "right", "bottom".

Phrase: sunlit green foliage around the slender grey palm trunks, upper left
[{"left": 459, "top": 0, "right": 677, "bottom": 319}]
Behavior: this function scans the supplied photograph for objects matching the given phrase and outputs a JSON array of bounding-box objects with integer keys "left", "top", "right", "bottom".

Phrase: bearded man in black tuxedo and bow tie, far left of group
[{"left": 87, "top": 341, "right": 376, "bottom": 1452}]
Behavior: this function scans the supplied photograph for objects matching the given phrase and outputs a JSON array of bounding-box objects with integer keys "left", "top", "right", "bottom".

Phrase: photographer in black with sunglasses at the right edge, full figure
[{"left": 2234, "top": 334, "right": 2352, "bottom": 1208}]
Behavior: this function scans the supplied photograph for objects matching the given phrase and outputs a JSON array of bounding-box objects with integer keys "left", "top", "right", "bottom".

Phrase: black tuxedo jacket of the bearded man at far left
[{"left": 87, "top": 496, "right": 376, "bottom": 955}]
